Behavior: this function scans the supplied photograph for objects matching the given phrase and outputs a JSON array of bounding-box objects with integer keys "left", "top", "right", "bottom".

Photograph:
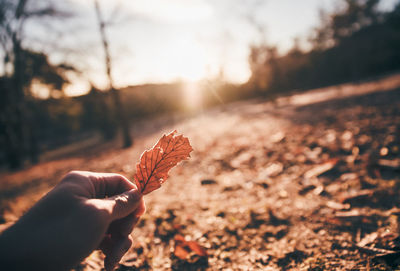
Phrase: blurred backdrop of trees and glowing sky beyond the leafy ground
[{"left": 0, "top": 0, "right": 400, "bottom": 169}]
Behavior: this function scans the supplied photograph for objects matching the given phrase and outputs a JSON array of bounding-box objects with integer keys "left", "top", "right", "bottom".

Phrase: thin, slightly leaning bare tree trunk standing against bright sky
[{"left": 94, "top": 0, "right": 132, "bottom": 148}]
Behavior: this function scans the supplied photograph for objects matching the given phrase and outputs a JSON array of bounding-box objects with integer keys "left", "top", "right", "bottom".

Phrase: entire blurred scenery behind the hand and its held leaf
[{"left": 0, "top": 0, "right": 400, "bottom": 271}]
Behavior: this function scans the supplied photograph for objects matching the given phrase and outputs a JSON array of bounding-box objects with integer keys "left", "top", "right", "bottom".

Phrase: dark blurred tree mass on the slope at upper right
[{"left": 249, "top": 0, "right": 400, "bottom": 95}]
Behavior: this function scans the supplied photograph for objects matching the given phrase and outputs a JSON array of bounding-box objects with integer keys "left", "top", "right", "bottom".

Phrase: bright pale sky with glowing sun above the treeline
[{"left": 17, "top": 0, "right": 397, "bottom": 95}]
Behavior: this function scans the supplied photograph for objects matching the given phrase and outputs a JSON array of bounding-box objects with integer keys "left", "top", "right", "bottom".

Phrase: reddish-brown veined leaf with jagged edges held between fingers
[{"left": 134, "top": 131, "right": 193, "bottom": 195}]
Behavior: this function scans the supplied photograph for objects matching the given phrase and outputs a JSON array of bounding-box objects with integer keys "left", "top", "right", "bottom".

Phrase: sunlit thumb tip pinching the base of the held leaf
[{"left": 106, "top": 188, "right": 143, "bottom": 220}]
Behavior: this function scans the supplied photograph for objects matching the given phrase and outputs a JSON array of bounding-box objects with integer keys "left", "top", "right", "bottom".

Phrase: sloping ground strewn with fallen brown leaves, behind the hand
[{"left": 0, "top": 76, "right": 400, "bottom": 270}]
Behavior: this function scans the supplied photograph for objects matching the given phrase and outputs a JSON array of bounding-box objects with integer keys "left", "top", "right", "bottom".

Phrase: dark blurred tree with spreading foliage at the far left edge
[{"left": 0, "top": 0, "right": 69, "bottom": 168}]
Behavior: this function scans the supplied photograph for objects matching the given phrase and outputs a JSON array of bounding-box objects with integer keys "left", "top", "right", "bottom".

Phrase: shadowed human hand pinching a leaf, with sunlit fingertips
[{"left": 0, "top": 171, "right": 145, "bottom": 271}]
